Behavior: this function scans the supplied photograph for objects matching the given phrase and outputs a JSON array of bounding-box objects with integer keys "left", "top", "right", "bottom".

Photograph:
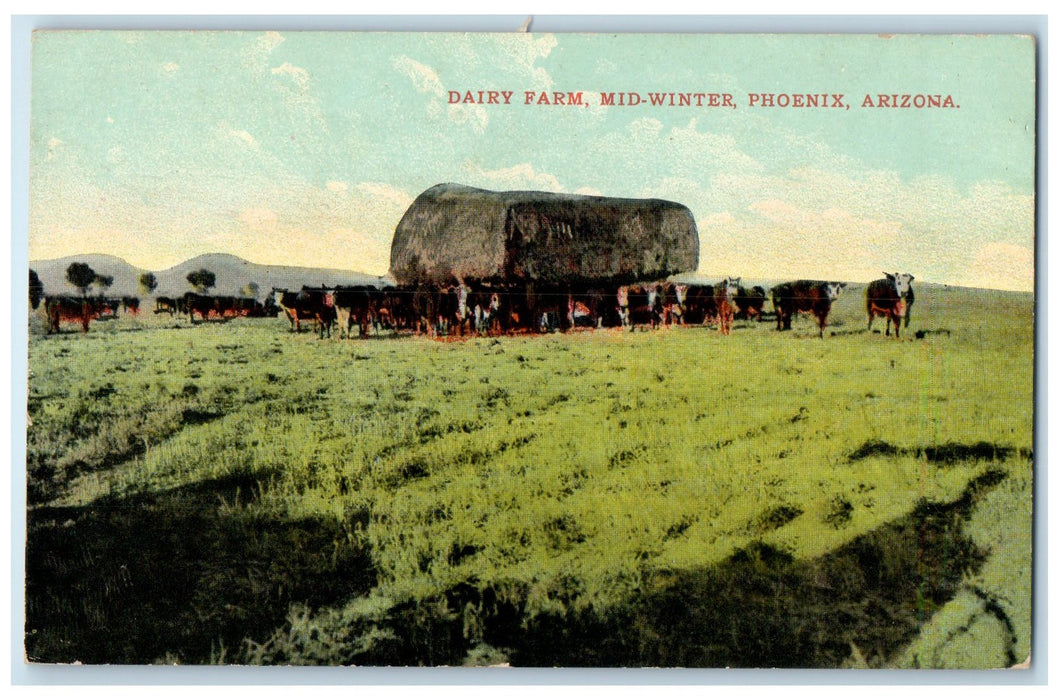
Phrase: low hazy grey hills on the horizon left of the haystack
[{"left": 30, "top": 253, "right": 392, "bottom": 299}]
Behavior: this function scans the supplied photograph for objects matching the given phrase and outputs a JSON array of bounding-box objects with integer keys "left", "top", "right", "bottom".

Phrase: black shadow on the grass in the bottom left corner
[{"left": 25, "top": 465, "right": 375, "bottom": 664}]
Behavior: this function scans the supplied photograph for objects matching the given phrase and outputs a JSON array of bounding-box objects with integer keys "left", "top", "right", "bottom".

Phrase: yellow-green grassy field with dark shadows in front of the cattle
[{"left": 25, "top": 286, "right": 1034, "bottom": 668}]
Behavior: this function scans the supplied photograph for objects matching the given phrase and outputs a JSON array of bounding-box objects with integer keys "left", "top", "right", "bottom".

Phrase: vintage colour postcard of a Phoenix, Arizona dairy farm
[{"left": 24, "top": 32, "right": 1037, "bottom": 668}]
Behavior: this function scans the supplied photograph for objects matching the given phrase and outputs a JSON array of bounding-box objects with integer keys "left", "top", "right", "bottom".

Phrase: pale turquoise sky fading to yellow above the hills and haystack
[{"left": 28, "top": 31, "right": 1036, "bottom": 290}]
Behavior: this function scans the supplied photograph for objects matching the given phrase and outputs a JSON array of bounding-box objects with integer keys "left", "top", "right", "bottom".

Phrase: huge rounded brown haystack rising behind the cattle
[{"left": 390, "top": 183, "right": 699, "bottom": 285}]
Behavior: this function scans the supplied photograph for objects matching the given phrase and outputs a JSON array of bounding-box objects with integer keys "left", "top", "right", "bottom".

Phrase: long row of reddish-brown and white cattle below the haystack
[{"left": 37, "top": 273, "right": 915, "bottom": 338}]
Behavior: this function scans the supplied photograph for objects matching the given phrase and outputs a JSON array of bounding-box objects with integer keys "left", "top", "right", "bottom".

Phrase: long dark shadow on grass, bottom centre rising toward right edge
[{"left": 372, "top": 470, "right": 1016, "bottom": 668}]
